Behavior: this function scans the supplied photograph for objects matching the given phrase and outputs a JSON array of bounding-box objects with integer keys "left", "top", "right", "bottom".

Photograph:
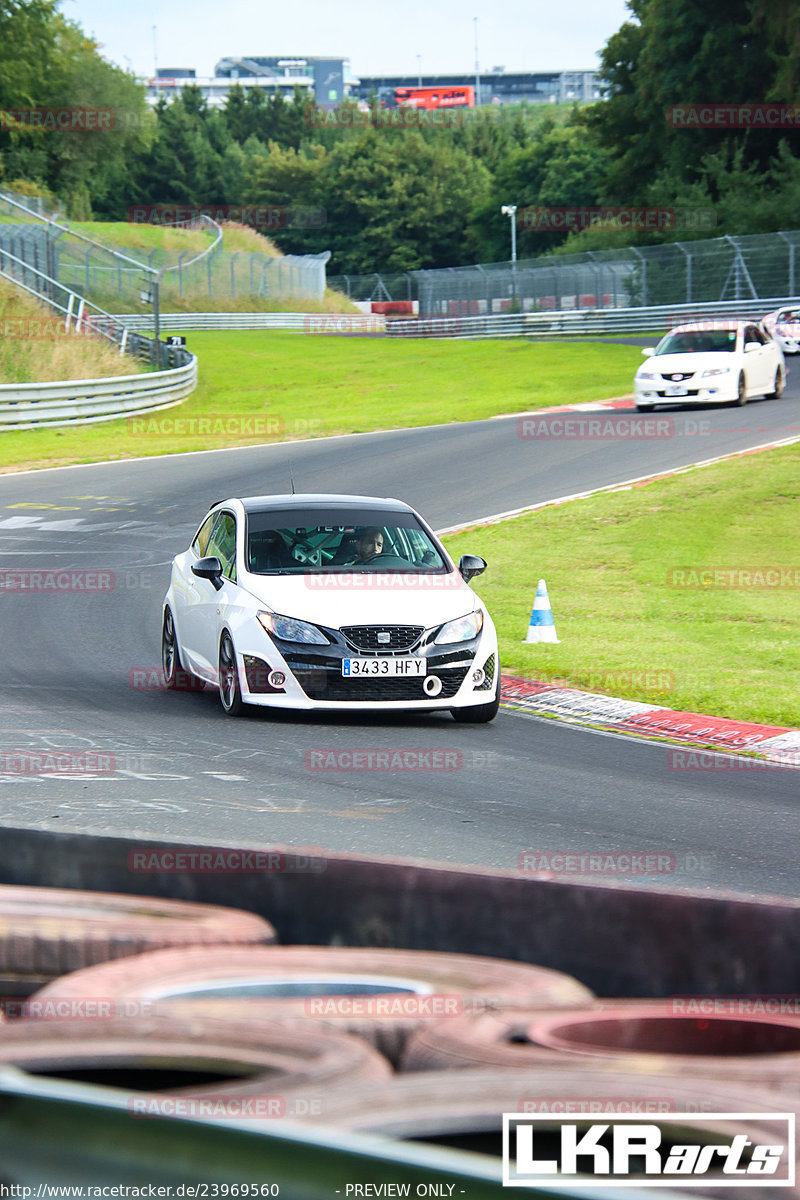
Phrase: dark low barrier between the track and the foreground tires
[{"left": 0, "top": 829, "right": 800, "bottom": 997}]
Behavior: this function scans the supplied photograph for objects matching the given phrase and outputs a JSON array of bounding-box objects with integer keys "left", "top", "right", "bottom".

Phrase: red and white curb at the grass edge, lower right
[{"left": 500, "top": 674, "right": 800, "bottom": 768}]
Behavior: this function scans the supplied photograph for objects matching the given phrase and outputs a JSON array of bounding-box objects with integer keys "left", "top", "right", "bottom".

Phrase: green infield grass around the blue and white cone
[{"left": 445, "top": 445, "right": 800, "bottom": 726}]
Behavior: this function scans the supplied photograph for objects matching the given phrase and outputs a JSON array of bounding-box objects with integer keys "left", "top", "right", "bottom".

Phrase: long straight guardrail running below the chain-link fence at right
[{"left": 386, "top": 296, "right": 800, "bottom": 338}]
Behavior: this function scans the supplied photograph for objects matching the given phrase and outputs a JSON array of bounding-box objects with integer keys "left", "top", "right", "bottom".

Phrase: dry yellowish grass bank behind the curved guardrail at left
[{"left": 0, "top": 281, "right": 140, "bottom": 384}]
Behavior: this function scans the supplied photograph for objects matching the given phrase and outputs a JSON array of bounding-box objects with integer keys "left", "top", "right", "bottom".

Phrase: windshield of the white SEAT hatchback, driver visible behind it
[{"left": 246, "top": 508, "right": 450, "bottom": 575}]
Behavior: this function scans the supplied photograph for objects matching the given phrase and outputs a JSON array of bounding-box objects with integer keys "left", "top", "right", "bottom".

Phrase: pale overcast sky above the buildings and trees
[{"left": 61, "top": 0, "right": 630, "bottom": 76}]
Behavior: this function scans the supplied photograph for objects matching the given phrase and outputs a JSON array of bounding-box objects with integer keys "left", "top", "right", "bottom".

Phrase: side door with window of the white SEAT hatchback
[{"left": 181, "top": 509, "right": 236, "bottom": 679}]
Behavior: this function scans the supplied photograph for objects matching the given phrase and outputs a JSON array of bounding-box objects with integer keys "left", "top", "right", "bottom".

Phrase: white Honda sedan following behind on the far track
[{"left": 633, "top": 320, "right": 786, "bottom": 412}]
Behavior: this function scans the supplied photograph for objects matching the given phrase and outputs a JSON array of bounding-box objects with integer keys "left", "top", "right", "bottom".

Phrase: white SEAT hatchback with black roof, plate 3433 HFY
[{"left": 162, "top": 496, "right": 500, "bottom": 722}]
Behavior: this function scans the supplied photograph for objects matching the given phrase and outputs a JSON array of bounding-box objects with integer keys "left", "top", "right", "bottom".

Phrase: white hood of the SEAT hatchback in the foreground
[{"left": 241, "top": 572, "right": 481, "bottom": 629}]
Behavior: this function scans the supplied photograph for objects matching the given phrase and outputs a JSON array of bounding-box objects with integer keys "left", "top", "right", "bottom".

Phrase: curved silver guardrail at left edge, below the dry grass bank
[{"left": 0, "top": 358, "right": 197, "bottom": 432}]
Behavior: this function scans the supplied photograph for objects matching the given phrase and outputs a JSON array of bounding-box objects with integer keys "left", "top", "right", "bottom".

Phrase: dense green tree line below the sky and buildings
[{"left": 0, "top": 0, "right": 800, "bottom": 274}]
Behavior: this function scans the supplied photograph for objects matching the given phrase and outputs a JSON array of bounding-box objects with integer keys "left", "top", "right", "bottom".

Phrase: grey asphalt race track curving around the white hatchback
[{"left": 0, "top": 388, "right": 800, "bottom": 896}]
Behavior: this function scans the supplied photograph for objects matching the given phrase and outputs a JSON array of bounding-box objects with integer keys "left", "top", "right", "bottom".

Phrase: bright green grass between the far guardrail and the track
[{"left": 2, "top": 336, "right": 639, "bottom": 467}]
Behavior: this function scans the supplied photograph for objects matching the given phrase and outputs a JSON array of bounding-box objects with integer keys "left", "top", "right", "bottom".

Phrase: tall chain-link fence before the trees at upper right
[{"left": 329, "top": 230, "right": 800, "bottom": 317}]
